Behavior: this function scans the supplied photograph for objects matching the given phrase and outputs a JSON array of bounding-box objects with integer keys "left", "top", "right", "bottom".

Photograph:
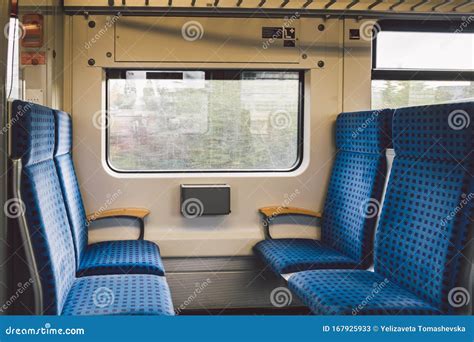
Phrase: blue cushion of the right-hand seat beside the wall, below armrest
[{"left": 254, "top": 239, "right": 358, "bottom": 274}]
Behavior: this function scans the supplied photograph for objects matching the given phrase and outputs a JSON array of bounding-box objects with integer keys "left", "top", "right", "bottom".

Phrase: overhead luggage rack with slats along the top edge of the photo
[{"left": 64, "top": 0, "right": 474, "bottom": 17}]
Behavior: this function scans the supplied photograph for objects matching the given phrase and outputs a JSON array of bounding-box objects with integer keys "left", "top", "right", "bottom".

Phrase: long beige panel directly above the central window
[{"left": 115, "top": 17, "right": 300, "bottom": 63}]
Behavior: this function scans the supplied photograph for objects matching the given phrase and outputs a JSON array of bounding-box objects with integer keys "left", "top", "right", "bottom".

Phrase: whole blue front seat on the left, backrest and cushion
[{"left": 9, "top": 101, "right": 174, "bottom": 315}]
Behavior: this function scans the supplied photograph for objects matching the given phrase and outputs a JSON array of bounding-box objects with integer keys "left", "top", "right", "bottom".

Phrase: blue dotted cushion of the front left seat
[{"left": 62, "top": 274, "right": 174, "bottom": 316}]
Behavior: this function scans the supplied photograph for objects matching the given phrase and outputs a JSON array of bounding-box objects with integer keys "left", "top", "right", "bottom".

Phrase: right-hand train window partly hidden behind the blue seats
[{"left": 372, "top": 21, "right": 474, "bottom": 108}]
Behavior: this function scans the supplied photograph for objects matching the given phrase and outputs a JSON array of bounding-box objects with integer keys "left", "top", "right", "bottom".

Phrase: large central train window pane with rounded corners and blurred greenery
[{"left": 106, "top": 70, "right": 303, "bottom": 173}]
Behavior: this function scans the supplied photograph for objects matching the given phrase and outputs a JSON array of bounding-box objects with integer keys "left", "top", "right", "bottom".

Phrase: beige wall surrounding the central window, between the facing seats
[{"left": 69, "top": 16, "right": 342, "bottom": 256}]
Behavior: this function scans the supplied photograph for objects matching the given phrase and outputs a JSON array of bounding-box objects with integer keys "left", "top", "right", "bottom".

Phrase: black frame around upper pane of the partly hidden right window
[{"left": 371, "top": 20, "right": 474, "bottom": 81}]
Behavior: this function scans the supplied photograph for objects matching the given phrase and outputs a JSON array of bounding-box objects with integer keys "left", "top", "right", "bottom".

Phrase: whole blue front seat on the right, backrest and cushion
[{"left": 289, "top": 102, "right": 474, "bottom": 315}]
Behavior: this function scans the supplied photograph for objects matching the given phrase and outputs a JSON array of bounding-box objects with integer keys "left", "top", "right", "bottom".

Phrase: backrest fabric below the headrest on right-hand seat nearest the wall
[{"left": 321, "top": 151, "right": 387, "bottom": 267}]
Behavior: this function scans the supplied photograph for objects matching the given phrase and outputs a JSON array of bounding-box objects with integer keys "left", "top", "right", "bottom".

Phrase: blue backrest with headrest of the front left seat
[{"left": 10, "top": 101, "right": 76, "bottom": 314}]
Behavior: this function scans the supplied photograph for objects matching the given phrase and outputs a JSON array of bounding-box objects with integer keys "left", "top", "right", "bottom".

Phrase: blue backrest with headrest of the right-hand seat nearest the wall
[{"left": 321, "top": 109, "right": 393, "bottom": 267}]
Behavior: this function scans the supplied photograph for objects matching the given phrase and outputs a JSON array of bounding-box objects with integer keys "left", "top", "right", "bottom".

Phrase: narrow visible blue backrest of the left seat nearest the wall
[{"left": 54, "top": 111, "right": 87, "bottom": 266}]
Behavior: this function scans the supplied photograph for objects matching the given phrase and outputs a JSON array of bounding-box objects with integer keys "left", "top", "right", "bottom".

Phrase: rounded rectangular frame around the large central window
[{"left": 104, "top": 67, "right": 305, "bottom": 175}]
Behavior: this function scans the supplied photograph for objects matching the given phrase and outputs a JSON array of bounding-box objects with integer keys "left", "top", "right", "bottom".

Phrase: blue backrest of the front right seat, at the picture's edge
[{"left": 374, "top": 102, "right": 474, "bottom": 312}]
